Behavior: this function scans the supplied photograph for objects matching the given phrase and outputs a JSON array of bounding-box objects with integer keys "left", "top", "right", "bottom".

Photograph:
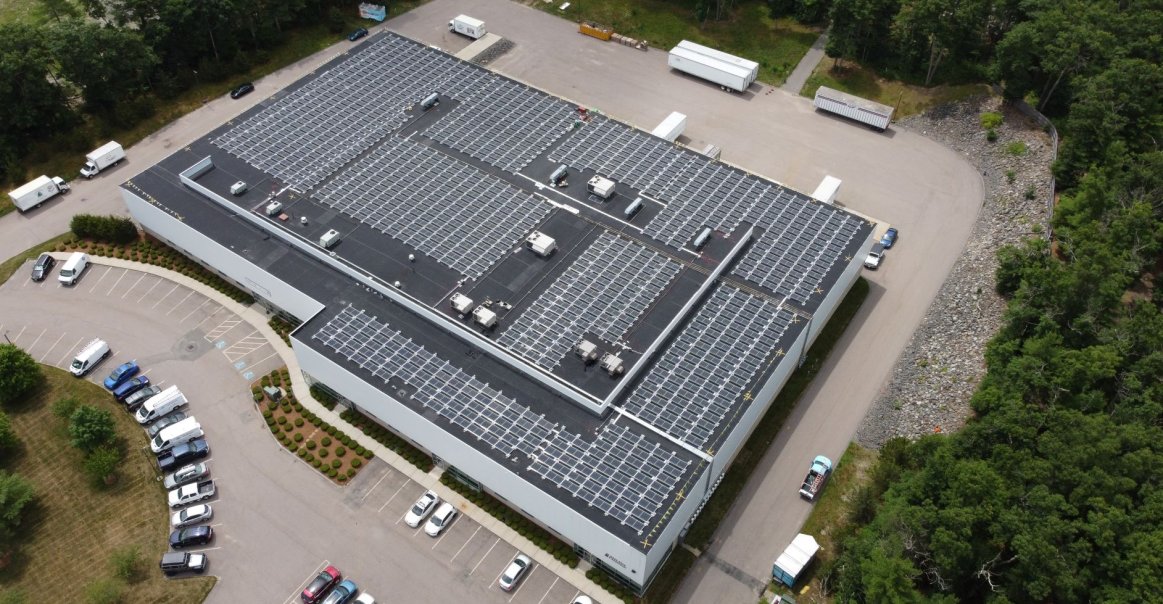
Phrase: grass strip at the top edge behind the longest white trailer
[{"left": 534, "top": 0, "right": 820, "bottom": 85}]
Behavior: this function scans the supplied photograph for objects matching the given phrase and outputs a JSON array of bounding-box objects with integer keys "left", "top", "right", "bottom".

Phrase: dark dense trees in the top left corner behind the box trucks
[{"left": 0, "top": 0, "right": 357, "bottom": 183}]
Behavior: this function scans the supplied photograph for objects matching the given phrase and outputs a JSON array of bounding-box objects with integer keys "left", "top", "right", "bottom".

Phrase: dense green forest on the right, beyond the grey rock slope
[{"left": 772, "top": 0, "right": 1163, "bottom": 603}]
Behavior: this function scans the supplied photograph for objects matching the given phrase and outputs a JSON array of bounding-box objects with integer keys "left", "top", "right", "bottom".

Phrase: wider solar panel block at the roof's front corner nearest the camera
[{"left": 529, "top": 424, "right": 691, "bottom": 535}]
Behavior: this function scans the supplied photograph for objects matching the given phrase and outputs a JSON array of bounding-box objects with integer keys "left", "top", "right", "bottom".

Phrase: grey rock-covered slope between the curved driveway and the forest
[{"left": 856, "top": 98, "right": 1054, "bottom": 448}]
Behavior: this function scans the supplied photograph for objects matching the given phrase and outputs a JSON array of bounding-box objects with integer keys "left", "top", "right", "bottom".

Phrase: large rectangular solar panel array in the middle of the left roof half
[{"left": 315, "top": 136, "right": 551, "bottom": 278}]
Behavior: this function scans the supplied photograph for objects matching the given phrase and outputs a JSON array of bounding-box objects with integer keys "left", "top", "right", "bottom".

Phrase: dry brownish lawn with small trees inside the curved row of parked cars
[{"left": 0, "top": 367, "right": 215, "bottom": 603}]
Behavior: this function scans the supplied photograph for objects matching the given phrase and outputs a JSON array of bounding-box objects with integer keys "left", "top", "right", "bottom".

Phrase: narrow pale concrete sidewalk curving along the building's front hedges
[{"left": 52, "top": 251, "right": 619, "bottom": 602}]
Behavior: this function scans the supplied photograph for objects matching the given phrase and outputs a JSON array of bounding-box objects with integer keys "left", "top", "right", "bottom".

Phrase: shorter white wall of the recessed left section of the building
[{"left": 121, "top": 189, "right": 323, "bottom": 321}]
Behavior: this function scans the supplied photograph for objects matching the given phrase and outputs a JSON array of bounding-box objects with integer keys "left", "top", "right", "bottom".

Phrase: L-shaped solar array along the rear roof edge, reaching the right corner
[{"left": 550, "top": 118, "right": 862, "bottom": 304}]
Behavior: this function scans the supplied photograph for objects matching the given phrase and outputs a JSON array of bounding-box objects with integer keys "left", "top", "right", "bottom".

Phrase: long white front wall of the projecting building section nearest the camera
[{"left": 291, "top": 337, "right": 647, "bottom": 584}]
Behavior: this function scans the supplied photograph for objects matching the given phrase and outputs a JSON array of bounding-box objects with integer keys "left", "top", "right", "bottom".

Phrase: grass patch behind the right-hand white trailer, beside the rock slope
[{"left": 800, "top": 57, "right": 990, "bottom": 120}]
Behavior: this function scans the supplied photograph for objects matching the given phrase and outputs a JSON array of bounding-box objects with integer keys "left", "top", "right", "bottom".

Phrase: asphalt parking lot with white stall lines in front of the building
[{"left": 0, "top": 262, "right": 595, "bottom": 604}]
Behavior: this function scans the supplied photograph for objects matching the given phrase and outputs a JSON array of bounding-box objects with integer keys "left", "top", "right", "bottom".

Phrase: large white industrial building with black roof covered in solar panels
[{"left": 122, "top": 33, "right": 873, "bottom": 589}]
